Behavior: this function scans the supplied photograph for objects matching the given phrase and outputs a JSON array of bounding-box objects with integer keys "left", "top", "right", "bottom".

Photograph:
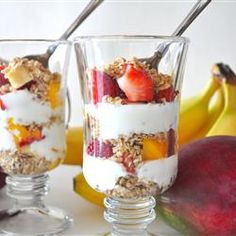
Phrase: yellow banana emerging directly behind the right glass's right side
[{"left": 179, "top": 76, "right": 220, "bottom": 145}]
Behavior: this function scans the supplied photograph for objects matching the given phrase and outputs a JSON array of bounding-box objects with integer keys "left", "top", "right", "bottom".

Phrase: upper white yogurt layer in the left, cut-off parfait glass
[{"left": 0, "top": 89, "right": 63, "bottom": 126}]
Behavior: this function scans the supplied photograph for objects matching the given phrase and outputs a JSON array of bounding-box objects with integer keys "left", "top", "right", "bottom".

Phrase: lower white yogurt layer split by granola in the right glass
[{"left": 83, "top": 154, "right": 178, "bottom": 192}]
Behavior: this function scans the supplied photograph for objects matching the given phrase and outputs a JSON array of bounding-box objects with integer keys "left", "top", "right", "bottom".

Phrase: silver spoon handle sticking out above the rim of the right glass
[{"left": 172, "top": 0, "right": 211, "bottom": 36}]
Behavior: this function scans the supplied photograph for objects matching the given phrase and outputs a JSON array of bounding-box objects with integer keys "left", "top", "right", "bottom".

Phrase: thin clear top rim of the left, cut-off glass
[{"left": 0, "top": 38, "right": 72, "bottom": 44}]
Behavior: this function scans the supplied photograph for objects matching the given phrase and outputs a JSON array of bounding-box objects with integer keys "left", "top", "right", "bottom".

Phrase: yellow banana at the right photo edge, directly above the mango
[{"left": 207, "top": 75, "right": 236, "bottom": 136}]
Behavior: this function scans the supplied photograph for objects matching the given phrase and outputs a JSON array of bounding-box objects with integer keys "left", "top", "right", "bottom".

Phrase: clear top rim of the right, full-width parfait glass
[{"left": 72, "top": 34, "right": 190, "bottom": 43}]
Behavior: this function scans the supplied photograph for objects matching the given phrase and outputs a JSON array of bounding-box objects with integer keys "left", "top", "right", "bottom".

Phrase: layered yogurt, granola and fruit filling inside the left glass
[{"left": 0, "top": 58, "right": 65, "bottom": 175}]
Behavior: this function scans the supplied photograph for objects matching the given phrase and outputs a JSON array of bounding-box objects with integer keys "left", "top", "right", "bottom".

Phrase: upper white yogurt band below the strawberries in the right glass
[{"left": 85, "top": 102, "right": 179, "bottom": 139}]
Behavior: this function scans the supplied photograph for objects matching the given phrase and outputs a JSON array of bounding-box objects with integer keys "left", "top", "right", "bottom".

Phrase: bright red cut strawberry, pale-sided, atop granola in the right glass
[{"left": 117, "top": 64, "right": 154, "bottom": 102}]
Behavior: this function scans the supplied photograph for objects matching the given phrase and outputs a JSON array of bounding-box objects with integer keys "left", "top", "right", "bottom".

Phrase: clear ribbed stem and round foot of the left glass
[{"left": 0, "top": 174, "right": 72, "bottom": 236}]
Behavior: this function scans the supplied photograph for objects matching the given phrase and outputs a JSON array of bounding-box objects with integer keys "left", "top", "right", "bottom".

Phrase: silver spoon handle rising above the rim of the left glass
[{"left": 59, "top": 0, "right": 104, "bottom": 40}]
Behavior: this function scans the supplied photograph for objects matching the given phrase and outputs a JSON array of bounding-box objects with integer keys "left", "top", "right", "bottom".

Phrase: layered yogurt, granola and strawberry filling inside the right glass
[{"left": 83, "top": 58, "right": 179, "bottom": 198}]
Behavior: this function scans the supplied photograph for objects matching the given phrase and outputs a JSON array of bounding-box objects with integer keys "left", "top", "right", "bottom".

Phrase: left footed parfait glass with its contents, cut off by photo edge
[{"left": 0, "top": 40, "right": 72, "bottom": 236}]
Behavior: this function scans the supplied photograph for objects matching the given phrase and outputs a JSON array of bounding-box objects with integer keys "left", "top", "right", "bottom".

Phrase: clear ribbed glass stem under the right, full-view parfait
[{"left": 104, "top": 197, "right": 156, "bottom": 236}]
